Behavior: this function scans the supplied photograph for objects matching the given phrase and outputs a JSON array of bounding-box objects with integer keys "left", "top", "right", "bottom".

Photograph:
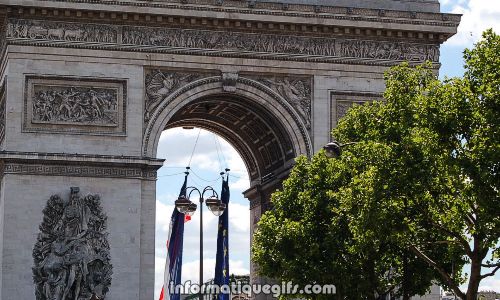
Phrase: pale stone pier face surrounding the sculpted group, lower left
[{"left": 0, "top": 151, "right": 162, "bottom": 300}]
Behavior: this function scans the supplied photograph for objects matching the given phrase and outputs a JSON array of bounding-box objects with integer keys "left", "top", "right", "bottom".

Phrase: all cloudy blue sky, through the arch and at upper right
[{"left": 155, "top": 0, "right": 500, "bottom": 299}]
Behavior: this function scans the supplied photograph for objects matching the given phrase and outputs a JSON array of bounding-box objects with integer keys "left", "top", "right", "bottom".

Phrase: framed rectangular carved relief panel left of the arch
[{"left": 23, "top": 76, "right": 126, "bottom": 135}]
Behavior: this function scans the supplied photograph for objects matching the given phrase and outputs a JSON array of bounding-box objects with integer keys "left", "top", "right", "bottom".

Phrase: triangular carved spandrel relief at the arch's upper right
[{"left": 247, "top": 75, "right": 312, "bottom": 129}]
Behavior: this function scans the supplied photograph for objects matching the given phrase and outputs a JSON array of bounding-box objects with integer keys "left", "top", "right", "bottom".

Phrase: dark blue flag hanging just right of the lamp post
[{"left": 214, "top": 176, "right": 230, "bottom": 300}]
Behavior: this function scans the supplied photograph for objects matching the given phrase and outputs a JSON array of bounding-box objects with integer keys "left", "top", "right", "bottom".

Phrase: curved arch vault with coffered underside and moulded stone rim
[{"left": 143, "top": 76, "right": 311, "bottom": 186}]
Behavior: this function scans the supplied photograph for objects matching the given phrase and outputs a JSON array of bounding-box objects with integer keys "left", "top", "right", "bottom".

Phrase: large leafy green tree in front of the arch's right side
[{"left": 253, "top": 30, "right": 500, "bottom": 300}]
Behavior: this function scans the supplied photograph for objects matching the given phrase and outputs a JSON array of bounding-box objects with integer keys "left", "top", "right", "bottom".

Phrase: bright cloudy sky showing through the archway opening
[{"left": 155, "top": 127, "right": 254, "bottom": 299}]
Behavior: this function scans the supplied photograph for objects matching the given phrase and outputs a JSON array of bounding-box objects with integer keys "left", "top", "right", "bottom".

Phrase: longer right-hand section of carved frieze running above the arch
[{"left": 122, "top": 26, "right": 439, "bottom": 61}]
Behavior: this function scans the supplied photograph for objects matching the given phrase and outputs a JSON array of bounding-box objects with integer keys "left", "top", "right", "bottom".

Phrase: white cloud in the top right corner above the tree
[{"left": 442, "top": 0, "right": 500, "bottom": 47}]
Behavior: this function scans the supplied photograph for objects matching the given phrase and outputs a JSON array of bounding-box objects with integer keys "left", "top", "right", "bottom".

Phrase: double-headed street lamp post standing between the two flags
[{"left": 175, "top": 186, "right": 226, "bottom": 300}]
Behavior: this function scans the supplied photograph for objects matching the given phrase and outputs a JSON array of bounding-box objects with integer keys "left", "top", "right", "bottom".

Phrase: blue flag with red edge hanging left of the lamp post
[{"left": 160, "top": 174, "right": 188, "bottom": 300}]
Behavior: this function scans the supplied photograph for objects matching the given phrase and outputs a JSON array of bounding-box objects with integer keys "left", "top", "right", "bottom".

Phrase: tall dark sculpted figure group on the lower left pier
[{"left": 33, "top": 187, "right": 113, "bottom": 300}]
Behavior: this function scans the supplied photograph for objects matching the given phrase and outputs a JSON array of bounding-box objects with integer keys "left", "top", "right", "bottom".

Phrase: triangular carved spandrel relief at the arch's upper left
[{"left": 144, "top": 70, "right": 209, "bottom": 122}]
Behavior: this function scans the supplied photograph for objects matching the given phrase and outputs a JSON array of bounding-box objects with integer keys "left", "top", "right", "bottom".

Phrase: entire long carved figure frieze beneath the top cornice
[{"left": 7, "top": 18, "right": 439, "bottom": 66}]
